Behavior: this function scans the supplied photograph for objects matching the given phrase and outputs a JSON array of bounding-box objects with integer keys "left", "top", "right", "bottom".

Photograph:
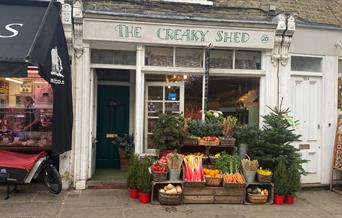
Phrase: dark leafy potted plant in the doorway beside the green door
[{"left": 113, "top": 134, "right": 134, "bottom": 170}]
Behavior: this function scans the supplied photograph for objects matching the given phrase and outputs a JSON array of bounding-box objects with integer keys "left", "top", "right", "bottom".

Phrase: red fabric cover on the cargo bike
[{"left": 0, "top": 150, "right": 46, "bottom": 171}]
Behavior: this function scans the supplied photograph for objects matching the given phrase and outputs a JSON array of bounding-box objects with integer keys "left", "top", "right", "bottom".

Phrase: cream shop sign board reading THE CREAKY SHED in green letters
[{"left": 83, "top": 19, "right": 275, "bottom": 49}]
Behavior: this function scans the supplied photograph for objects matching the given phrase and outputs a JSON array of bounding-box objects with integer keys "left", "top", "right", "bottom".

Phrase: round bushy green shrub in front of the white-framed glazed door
[{"left": 153, "top": 114, "right": 185, "bottom": 150}]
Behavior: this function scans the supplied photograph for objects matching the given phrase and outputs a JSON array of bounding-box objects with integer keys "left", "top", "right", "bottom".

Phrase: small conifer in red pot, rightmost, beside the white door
[{"left": 285, "top": 162, "right": 301, "bottom": 204}]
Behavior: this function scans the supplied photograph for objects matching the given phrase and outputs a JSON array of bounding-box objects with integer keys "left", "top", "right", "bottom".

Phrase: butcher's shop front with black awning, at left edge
[{"left": 0, "top": 1, "right": 73, "bottom": 166}]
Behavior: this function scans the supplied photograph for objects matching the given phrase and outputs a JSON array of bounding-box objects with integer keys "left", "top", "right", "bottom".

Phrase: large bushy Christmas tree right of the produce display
[{"left": 248, "top": 107, "right": 306, "bottom": 174}]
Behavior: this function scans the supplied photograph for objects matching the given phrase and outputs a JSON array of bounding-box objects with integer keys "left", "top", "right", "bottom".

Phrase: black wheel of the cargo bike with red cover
[{"left": 43, "top": 165, "right": 62, "bottom": 195}]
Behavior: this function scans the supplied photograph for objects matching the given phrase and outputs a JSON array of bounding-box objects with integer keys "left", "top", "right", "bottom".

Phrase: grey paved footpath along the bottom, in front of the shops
[{"left": 0, "top": 185, "right": 342, "bottom": 218}]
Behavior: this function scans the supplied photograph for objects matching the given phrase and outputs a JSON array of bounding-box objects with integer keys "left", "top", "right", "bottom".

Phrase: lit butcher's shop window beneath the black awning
[{"left": 0, "top": 73, "right": 53, "bottom": 147}]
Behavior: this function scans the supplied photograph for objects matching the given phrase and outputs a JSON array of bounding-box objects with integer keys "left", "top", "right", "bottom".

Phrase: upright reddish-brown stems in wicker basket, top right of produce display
[{"left": 220, "top": 116, "right": 237, "bottom": 146}]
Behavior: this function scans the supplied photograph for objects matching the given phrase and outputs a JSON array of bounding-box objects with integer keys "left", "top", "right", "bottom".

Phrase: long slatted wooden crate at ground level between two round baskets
[{"left": 183, "top": 186, "right": 246, "bottom": 204}]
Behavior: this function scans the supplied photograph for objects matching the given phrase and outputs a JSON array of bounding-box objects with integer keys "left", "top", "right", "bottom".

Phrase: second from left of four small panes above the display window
[{"left": 176, "top": 48, "right": 203, "bottom": 68}]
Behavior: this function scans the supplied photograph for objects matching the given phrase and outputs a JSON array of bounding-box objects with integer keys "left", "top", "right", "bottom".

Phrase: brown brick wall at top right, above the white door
[{"left": 212, "top": 0, "right": 342, "bottom": 26}]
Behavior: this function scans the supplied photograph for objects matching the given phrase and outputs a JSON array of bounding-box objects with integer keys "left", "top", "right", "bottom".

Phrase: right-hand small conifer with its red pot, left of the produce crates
[{"left": 137, "top": 157, "right": 152, "bottom": 204}]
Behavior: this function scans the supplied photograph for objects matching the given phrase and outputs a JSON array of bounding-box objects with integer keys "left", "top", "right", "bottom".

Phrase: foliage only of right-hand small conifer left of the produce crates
[{"left": 137, "top": 157, "right": 152, "bottom": 193}]
